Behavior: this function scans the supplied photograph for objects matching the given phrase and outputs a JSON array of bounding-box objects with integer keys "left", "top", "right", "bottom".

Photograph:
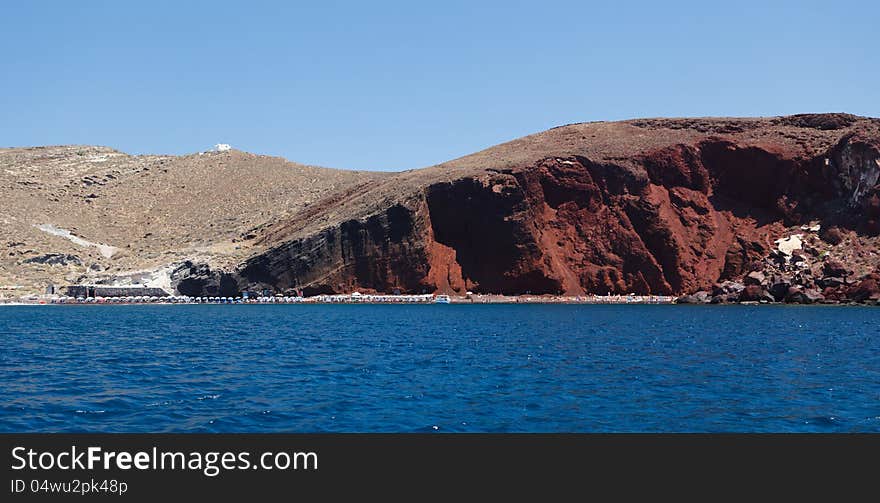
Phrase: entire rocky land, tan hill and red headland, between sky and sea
[{"left": 0, "top": 114, "right": 880, "bottom": 302}]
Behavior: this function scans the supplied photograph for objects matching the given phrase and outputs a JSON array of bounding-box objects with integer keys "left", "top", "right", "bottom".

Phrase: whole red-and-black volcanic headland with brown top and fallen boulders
[{"left": 178, "top": 114, "right": 880, "bottom": 300}]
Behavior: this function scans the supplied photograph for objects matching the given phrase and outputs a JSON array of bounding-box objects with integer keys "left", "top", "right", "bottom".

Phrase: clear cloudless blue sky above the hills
[{"left": 0, "top": 0, "right": 880, "bottom": 170}]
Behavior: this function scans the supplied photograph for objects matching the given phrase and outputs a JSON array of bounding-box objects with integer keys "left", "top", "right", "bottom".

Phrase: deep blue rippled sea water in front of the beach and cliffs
[{"left": 0, "top": 305, "right": 880, "bottom": 433}]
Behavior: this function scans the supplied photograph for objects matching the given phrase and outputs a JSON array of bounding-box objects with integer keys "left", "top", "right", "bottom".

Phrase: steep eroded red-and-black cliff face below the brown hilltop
[{"left": 220, "top": 121, "right": 880, "bottom": 300}]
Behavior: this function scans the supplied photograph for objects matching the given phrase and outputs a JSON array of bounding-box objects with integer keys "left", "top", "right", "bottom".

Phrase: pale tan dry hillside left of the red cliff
[{"left": 0, "top": 146, "right": 383, "bottom": 294}]
